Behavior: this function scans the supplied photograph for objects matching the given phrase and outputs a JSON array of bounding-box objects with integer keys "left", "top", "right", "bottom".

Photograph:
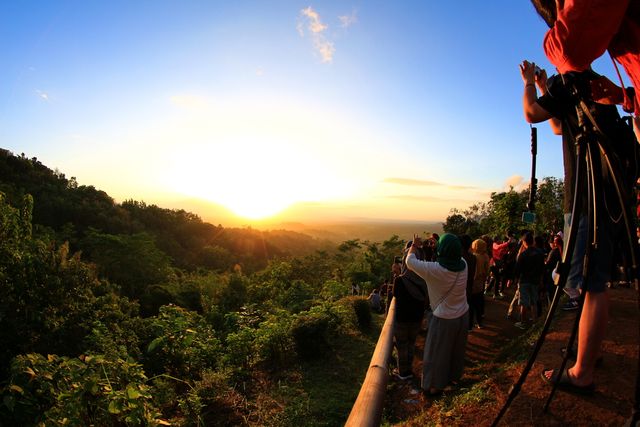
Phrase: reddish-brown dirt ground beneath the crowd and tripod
[{"left": 385, "top": 287, "right": 640, "bottom": 426}]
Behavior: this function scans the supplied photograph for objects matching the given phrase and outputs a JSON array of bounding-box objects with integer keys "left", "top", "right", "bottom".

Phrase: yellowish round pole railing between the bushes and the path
[{"left": 345, "top": 298, "right": 396, "bottom": 427}]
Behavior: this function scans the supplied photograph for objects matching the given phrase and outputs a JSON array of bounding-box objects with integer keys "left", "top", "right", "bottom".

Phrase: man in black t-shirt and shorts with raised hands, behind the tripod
[{"left": 520, "top": 61, "right": 635, "bottom": 394}]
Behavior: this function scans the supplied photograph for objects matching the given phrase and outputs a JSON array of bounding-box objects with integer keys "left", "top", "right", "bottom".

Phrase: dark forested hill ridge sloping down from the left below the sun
[{"left": 0, "top": 149, "right": 328, "bottom": 271}]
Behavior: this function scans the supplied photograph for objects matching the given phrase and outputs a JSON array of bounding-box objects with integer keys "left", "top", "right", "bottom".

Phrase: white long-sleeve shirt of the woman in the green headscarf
[{"left": 406, "top": 253, "right": 469, "bottom": 319}]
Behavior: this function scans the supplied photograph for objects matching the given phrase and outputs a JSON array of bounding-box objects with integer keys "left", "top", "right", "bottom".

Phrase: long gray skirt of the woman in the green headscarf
[{"left": 422, "top": 311, "right": 469, "bottom": 390}]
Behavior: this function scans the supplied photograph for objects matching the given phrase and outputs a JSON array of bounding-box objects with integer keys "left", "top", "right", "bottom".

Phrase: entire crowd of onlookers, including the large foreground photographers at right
[{"left": 368, "top": 0, "right": 640, "bottom": 425}]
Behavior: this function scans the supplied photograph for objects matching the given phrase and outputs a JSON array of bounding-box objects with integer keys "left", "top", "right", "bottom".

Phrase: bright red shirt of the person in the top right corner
[{"left": 544, "top": 0, "right": 640, "bottom": 114}]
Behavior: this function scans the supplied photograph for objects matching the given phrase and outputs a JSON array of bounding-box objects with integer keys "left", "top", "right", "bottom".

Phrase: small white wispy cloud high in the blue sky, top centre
[{"left": 296, "top": 6, "right": 358, "bottom": 63}]
